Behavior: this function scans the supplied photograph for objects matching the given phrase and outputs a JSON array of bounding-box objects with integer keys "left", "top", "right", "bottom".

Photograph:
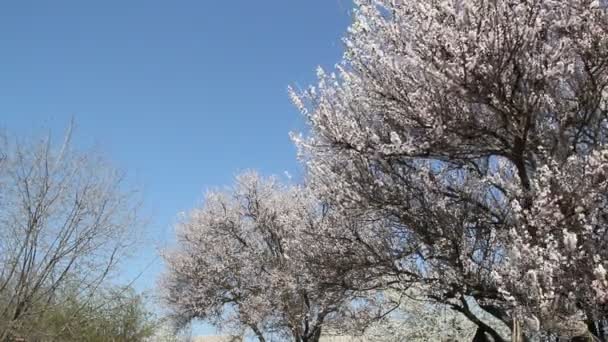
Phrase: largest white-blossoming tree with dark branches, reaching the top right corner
[{"left": 291, "top": 0, "right": 608, "bottom": 341}]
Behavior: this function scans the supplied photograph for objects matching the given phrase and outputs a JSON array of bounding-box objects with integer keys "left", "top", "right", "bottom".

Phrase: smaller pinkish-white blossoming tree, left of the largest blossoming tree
[{"left": 161, "top": 172, "right": 384, "bottom": 342}]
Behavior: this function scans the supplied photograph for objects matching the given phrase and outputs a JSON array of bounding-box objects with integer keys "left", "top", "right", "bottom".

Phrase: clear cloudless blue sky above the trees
[{"left": 0, "top": 0, "right": 352, "bottom": 336}]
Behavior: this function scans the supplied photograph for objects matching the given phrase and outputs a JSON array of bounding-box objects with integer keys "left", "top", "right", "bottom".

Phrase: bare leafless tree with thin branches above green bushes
[{"left": 0, "top": 127, "right": 137, "bottom": 341}]
